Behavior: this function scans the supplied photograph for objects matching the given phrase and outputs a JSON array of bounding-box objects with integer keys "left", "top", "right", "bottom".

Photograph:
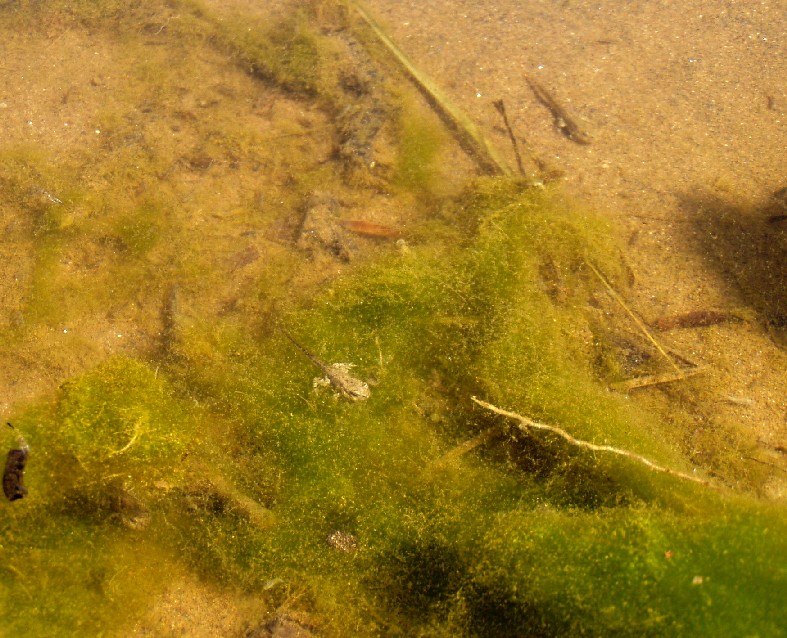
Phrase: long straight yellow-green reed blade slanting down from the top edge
[{"left": 348, "top": 0, "right": 511, "bottom": 176}]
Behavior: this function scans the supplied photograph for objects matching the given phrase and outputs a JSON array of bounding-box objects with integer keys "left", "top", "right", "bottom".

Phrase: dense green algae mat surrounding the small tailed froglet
[{"left": 3, "top": 183, "right": 787, "bottom": 636}]
